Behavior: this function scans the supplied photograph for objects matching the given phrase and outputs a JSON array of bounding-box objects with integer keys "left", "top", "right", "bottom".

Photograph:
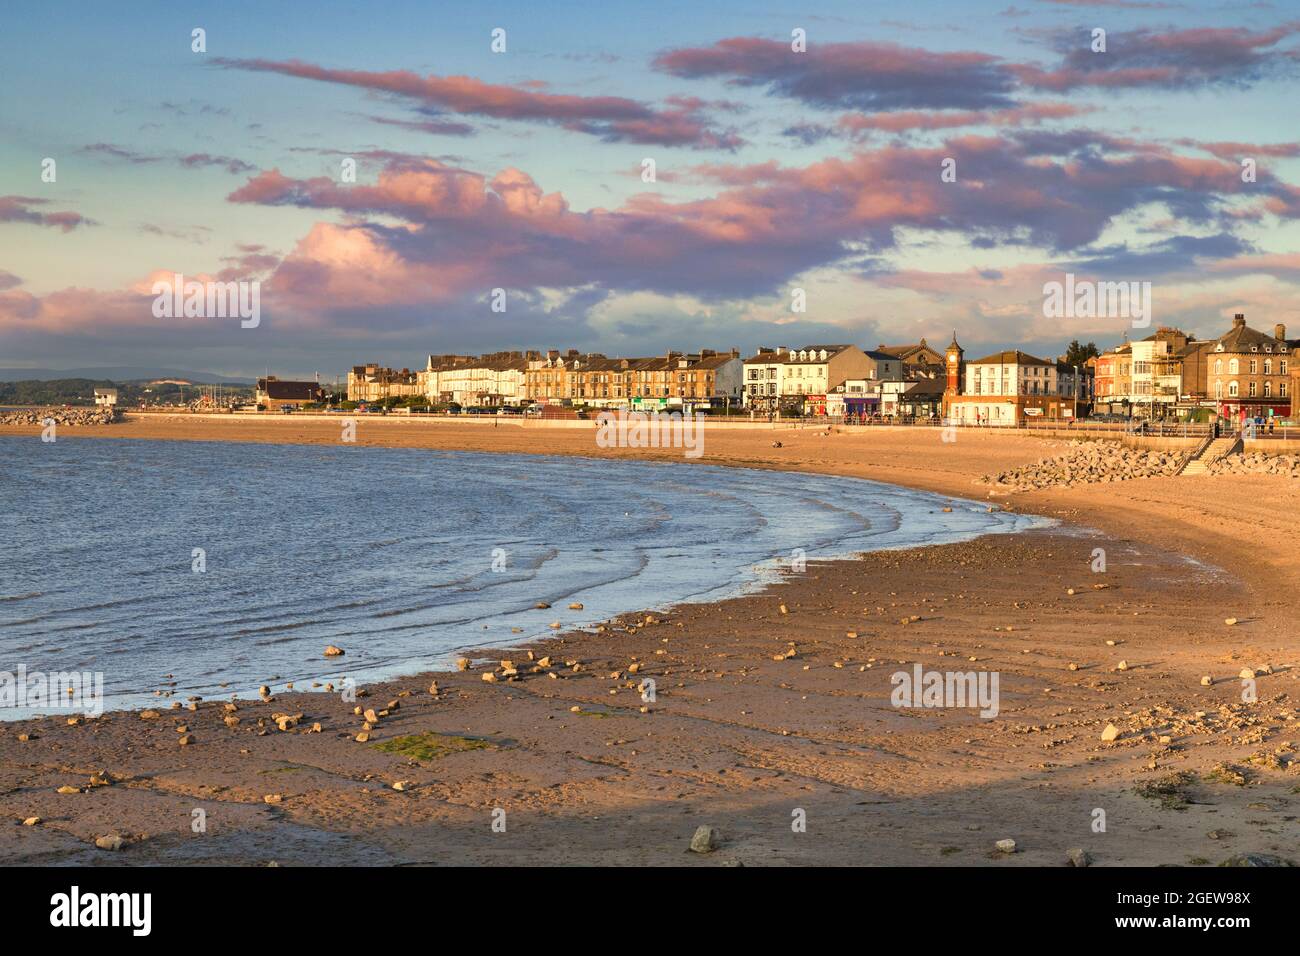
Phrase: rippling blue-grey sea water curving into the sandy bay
[{"left": 0, "top": 437, "right": 1043, "bottom": 719}]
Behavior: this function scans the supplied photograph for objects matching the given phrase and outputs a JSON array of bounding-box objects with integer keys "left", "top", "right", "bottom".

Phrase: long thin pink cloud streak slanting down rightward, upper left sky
[{"left": 215, "top": 57, "right": 742, "bottom": 151}]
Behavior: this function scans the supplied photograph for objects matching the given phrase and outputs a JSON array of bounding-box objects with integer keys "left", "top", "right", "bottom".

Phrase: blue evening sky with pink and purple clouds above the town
[{"left": 0, "top": 0, "right": 1300, "bottom": 377}]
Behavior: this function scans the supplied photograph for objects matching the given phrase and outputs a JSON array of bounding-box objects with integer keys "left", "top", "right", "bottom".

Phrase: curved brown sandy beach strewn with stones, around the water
[{"left": 0, "top": 416, "right": 1300, "bottom": 866}]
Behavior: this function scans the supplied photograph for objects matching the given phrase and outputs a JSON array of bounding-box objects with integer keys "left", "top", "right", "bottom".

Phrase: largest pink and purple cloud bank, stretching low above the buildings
[{"left": 213, "top": 129, "right": 1300, "bottom": 325}]
